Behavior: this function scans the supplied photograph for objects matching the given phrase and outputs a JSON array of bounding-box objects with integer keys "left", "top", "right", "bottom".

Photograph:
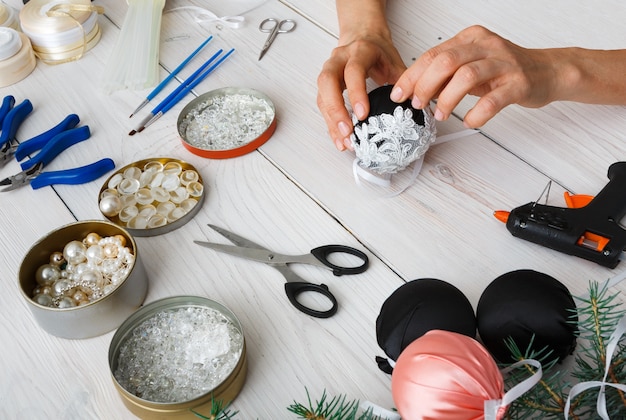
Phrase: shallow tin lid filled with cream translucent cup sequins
[{"left": 98, "top": 157, "right": 206, "bottom": 237}]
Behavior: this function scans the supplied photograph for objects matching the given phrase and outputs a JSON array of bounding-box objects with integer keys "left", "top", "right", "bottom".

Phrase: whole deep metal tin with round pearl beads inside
[{"left": 18, "top": 220, "right": 148, "bottom": 339}]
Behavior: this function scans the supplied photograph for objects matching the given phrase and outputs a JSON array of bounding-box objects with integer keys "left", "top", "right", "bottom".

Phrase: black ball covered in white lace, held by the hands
[{"left": 350, "top": 85, "right": 437, "bottom": 174}]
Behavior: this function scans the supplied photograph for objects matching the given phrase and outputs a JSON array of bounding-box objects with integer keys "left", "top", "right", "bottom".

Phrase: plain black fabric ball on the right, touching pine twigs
[{"left": 476, "top": 270, "right": 578, "bottom": 363}]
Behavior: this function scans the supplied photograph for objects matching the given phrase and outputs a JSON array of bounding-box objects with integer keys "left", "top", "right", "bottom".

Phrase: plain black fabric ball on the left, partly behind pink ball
[{"left": 376, "top": 279, "right": 476, "bottom": 373}]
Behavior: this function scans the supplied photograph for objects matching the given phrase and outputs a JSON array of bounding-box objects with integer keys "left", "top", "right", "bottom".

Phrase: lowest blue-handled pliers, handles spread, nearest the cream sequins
[{"left": 0, "top": 126, "right": 115, "bottom": 192}]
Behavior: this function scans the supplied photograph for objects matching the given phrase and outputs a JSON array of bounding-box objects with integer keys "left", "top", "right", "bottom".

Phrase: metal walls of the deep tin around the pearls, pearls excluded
[{"left": 18, "top": 220, "right": 148, "bottom": 339}]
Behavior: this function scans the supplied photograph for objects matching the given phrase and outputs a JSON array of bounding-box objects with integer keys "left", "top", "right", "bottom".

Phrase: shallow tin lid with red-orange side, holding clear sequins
[{"left": 177, "top": 87, "right": 276, "bottom": 159}]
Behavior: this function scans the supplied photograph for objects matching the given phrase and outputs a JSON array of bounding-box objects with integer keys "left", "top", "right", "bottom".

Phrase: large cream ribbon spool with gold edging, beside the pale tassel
[{"left": 20, "top": 0, "right": 104, "bottom": 64}]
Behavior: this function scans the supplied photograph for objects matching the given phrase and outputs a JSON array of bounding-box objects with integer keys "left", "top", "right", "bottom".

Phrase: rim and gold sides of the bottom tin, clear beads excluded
[{"left": 109, "top": 296, "right": 248, "bottom": 419}]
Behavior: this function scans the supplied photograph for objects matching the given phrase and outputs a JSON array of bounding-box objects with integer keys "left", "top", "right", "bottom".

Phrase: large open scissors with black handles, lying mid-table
[{"left": 194, "top": 224, "right": 369, "bottom": 318}]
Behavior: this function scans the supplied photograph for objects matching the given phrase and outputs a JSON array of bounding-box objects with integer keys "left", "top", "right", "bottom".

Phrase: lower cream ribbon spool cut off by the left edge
[{"left": 0, "top": 27, "right": 37, "bottom": 87}]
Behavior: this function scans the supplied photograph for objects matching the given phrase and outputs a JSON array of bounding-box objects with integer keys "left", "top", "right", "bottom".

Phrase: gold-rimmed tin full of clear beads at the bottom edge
[{"left": 109, "top": 296, "right": 248, "bottom": 419}]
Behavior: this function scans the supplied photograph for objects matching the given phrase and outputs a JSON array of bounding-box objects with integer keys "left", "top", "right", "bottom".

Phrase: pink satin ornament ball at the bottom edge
[{"left": 391, "top": 330, "right": 506, "bottom": 420}]
